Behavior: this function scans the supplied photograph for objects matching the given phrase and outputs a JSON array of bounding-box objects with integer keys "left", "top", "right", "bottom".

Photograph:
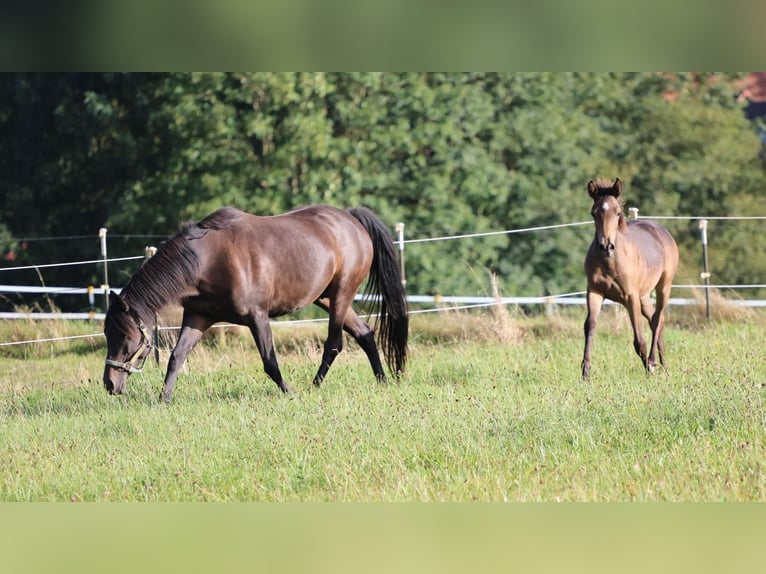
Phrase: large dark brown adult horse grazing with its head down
[{"left": 104, "top": 206, "right": 408, "bottom": 402}]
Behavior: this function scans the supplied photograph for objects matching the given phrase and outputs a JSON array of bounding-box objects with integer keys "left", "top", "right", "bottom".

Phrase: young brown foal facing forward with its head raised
[{"left": 582, "top": 178, "right": 678, "bottom": 378}]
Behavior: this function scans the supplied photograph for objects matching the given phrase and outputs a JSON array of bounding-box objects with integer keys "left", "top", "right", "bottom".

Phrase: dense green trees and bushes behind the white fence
[{"left": 0, "top": 72, "right": 766, "bottom": 308}]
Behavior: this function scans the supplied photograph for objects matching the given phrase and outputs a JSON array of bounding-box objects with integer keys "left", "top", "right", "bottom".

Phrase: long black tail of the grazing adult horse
[{"left": 348, "top": 207, "right": 409, "bottom": 375}]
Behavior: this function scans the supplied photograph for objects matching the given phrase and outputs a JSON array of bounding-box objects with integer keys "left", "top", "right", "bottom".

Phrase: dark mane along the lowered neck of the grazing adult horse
[{"left": 122, "top": 208, "right": 240, "bottom": 321}]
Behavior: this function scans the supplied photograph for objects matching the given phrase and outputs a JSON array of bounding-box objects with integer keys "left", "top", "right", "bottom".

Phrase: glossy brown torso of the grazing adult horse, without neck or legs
[{"left": 190, "top": 205, "right": 373, "bottom": 315}]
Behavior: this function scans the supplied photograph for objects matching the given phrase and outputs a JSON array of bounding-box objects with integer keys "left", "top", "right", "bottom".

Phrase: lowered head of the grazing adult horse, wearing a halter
[{"left": 104, "top": 292, "right": 152, "bottom": 395}]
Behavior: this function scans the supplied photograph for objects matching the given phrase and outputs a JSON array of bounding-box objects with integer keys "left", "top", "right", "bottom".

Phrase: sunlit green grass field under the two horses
[{"left": 0, "top": 307, "right": 766, "bottom": 501}]
